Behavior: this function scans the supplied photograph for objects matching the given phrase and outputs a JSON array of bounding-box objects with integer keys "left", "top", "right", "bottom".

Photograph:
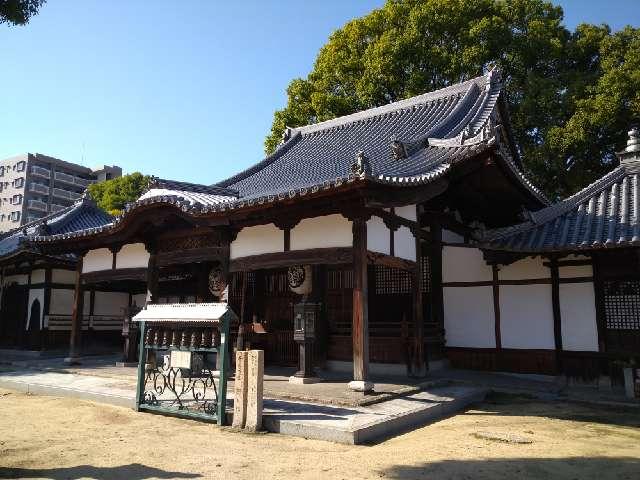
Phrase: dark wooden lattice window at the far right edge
[{"left": 604, "top": 280, "right": 640, "bottom": 330}]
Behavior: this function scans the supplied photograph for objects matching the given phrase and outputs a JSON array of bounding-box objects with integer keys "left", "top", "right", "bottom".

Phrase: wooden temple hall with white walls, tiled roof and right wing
[{"left": 0, "top": 70, "right": 640, "bottom": 390}]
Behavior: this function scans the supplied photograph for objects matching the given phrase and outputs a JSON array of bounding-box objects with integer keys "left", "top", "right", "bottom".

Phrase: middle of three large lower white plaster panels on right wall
[{"left": 500, "top": 284, "right": 555, "bottom": 349}]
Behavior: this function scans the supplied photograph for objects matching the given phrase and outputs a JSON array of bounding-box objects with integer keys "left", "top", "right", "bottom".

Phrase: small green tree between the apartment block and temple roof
[{"left": 89, "top": 172, "right": 149, "bottom": 215}]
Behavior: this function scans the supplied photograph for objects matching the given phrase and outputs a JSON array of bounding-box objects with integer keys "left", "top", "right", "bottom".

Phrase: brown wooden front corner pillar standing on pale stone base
[{"left": 349, "top": 217, "right": 373, "bottom": 392}]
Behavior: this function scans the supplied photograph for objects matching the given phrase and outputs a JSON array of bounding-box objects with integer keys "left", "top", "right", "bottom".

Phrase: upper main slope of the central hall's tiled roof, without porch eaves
[{"left": 218, "top": 68, "right": 502, "bottom": 200}]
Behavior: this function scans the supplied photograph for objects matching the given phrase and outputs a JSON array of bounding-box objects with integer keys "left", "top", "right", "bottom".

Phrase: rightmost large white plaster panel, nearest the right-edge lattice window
[{"left": 560, "top": 282, "right": 598, "bottom": 352}]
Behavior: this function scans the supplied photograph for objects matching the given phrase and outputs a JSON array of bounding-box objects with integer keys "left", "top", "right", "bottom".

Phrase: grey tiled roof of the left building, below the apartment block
[{"left": 0, "top": 196, "right": 113, "bottom": 258}]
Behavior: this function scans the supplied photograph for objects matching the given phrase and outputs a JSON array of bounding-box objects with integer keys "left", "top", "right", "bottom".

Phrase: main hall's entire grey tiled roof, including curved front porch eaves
[{"left": 32, "top": 70, "right": 548, "bottom": 242}]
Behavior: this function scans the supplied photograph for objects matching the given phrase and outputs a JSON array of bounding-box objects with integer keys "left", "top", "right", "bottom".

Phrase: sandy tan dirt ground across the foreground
[{"left": 0, "top": 390, "right": 640, "bottom": 480}]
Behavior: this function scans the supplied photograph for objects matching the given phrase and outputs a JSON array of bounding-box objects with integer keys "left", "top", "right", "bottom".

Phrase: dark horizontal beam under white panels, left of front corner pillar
[{"left": 229, "top": 247, "right": 353, "bottom": 272}]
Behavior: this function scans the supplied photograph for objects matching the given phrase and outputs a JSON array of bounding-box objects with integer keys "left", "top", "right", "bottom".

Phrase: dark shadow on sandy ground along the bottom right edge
[{"left": 379, "top": 457, "right": 640, "bottom": 480}]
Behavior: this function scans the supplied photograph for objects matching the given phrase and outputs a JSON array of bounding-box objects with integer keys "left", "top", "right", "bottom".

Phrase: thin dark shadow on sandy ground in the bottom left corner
[{"left": 0, "top": 463, "right": 201, "bottom": 480}]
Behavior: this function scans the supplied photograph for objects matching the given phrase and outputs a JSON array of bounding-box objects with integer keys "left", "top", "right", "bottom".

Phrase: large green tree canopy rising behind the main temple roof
[{"left": 265, "top": 0, "right": 640, "bottom": 198}]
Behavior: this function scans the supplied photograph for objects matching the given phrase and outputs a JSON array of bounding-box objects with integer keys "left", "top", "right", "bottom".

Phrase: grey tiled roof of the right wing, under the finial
[{"left": 481, "top": 159, "right": 640, "bottom": 253}]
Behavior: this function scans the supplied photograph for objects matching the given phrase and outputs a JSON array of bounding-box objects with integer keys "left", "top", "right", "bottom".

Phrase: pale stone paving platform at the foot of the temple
[{"left": 0, "top": 359, "right": 487, "bottom": 444}]
